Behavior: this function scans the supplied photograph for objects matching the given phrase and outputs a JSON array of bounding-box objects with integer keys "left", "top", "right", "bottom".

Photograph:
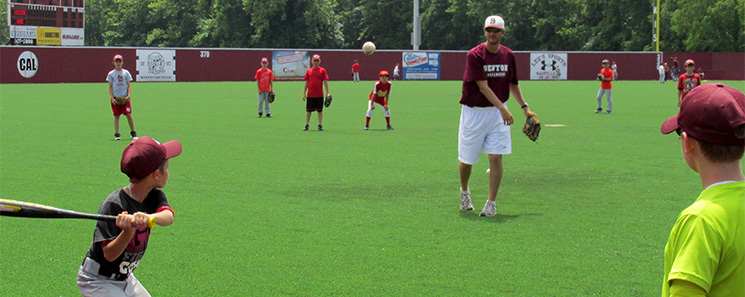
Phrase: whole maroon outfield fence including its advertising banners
[{"left": 0, "top": 46, "right": 745, "bottom": 83}]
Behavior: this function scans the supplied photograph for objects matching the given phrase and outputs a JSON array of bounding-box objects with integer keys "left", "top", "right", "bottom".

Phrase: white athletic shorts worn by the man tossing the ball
[{"left": 458, "top": 105, "right": 512, "bottom": 165}]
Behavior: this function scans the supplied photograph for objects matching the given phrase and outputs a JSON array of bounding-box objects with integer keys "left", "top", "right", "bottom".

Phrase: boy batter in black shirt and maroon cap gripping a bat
[{"left": 77, "top": 136, "right": 181, "bottom": 297}]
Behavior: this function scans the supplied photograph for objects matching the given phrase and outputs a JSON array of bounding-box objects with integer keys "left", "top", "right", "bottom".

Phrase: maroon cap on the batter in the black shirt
[{"left": 121, "top": 136, "right": 181, "bottom": 179}]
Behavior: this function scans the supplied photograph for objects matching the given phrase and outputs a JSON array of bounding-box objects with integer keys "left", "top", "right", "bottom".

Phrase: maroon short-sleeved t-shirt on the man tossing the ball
[{"left": 460, "top": 43, "right": 518, "bottom": 107}]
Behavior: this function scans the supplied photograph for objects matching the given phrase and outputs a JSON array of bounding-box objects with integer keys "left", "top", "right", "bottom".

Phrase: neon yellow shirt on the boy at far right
[{"left": 662, "top": 182, "right": 745, "bottom": 297}]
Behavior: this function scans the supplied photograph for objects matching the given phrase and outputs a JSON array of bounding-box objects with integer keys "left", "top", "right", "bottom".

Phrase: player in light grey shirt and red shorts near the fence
[{"left": 106, "top": 55, "right": 137, "bottom": 140}]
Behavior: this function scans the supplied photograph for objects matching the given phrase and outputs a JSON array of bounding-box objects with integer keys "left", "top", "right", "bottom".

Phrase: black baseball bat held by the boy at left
[{"left": 0, "top": 199, "right": 155, "bottom": 229}]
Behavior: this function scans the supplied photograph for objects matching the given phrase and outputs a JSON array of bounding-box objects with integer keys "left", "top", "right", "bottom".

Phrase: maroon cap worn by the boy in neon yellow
[{"left": 660, "top": 83, "right": 745, "bottom": 146}]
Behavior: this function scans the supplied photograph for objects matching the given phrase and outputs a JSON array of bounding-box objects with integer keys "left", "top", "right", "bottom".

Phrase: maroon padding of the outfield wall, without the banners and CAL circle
[{"left": 0, "top": 46, "right": 745, "bottom": 83}]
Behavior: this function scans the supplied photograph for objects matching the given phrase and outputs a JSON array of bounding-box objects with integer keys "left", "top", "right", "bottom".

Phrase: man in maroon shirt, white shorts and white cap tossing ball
[{"left": 458, "top": 15, "right": 535, "bottom": 217}]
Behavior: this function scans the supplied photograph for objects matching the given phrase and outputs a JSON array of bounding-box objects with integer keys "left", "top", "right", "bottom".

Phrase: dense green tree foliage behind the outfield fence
[{"left": 0, "top": 0, "right": 745, "bottom": 52}]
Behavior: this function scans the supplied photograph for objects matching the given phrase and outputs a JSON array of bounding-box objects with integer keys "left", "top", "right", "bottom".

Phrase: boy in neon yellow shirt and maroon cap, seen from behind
[{"left": 661, "top": 84, "right": 745, "bottom": 297}]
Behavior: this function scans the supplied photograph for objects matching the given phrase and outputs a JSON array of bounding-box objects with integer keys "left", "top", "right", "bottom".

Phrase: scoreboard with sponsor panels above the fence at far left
[{"left": 6, "top": 0, "right": 85, "bottom": 45}]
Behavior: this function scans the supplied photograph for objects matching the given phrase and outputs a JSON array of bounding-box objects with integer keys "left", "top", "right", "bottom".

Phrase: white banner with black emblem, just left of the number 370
[{"left": 136, "top": 49, "right": 176, "bottom": 81}]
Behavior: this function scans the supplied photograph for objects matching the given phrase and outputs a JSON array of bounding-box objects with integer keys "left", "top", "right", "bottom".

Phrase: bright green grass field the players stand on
[{"left": 0, "top": 81, "right": 745, "bottom": 296}]
